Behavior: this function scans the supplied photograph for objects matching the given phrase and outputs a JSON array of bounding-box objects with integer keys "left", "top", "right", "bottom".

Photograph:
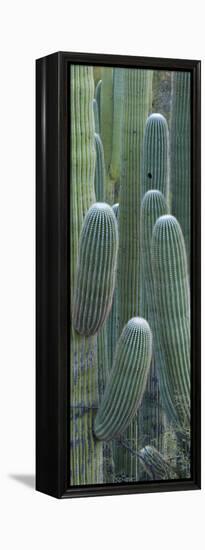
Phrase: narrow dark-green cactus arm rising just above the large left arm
[{"left": 95, "top": 133, "right": 105, "bottom": 202}]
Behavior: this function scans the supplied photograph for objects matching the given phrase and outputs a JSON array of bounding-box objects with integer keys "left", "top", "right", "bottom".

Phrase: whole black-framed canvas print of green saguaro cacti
[{"left": 36, "top": 52, "right": 200, "bottom": 498}]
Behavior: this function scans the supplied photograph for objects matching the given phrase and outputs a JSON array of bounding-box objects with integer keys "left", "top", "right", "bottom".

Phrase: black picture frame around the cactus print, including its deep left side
[{"left": 36, "top": 52, "right": 201, "bottom": 498}]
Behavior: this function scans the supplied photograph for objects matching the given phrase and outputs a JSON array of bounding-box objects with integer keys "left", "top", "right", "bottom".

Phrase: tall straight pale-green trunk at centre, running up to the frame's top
[{"left": 115, "top": 69, "right": 152, "bottom": 479}]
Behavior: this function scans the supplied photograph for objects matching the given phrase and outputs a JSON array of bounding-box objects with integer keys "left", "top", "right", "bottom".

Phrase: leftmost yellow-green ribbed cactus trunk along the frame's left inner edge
[{"left": 68, "top": 65, "right": 103, "bottom": 485}]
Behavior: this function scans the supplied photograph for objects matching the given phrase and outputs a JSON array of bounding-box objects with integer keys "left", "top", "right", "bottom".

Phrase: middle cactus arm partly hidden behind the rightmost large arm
[{"left": 138, "top": 190, "right": 168, "bottom": 471}]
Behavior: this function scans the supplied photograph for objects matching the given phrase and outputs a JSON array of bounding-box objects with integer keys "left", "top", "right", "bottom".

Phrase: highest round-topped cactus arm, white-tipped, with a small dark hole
[{"left": 142, "top": 113, "right": 169, "bottom": 202}]
